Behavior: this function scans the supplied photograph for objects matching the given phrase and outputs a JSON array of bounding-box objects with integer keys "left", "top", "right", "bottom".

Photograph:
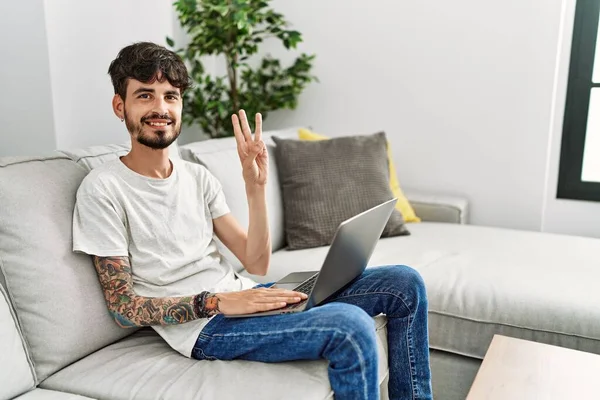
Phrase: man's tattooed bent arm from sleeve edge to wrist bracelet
[{"left": 94, "top": 256, "right": 220, "bottom": 328}]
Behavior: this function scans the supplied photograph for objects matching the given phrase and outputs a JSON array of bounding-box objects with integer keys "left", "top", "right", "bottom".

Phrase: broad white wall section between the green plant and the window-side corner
[{"left": 265, "top": 0, "right": 562, "bottom": 230}]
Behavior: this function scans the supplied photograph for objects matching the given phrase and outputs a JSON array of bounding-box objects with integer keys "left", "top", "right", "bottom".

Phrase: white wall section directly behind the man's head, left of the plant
[{"left": 43, "top": 0, "right": 173, "bottom": 149}]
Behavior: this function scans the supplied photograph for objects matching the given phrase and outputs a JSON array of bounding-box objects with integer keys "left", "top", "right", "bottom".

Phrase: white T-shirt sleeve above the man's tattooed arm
[{"left": 73, "top": 193, "right": 129, "bottom": 257}]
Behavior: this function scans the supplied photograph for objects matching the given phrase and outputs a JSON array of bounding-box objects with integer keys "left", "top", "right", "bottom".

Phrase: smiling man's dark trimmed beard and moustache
[{"left": 123, "top": 110, "right": 181, "bottom": 150}]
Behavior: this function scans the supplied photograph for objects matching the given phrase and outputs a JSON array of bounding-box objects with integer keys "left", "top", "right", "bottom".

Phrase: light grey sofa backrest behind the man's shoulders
[{"left": 0, "top": 128, "right": 298, "bottom": 382}]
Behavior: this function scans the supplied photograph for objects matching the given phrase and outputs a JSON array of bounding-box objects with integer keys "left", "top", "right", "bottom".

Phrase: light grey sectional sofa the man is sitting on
[{"left": 0, "top": 127, "right": 600, "bottom": 400}]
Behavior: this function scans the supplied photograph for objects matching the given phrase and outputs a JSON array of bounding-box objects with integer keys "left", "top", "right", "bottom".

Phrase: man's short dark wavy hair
[{"left": 108, "top": 42, "right": 192, "bottom": 100}]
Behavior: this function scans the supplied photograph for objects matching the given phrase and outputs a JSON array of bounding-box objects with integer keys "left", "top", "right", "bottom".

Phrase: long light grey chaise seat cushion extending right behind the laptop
[{"left": 245, "top": 222, "right": 600, "bottom": 359}]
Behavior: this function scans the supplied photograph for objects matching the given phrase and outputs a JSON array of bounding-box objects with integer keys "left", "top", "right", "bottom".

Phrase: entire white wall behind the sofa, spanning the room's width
[{"left": 0, "top": 0, "right": 600, "bottom": 236}]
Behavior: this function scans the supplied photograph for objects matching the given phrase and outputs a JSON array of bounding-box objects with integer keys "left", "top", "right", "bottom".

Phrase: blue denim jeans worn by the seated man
[{"left": 192, "top": 265, "right": 433, "bottom": 400}]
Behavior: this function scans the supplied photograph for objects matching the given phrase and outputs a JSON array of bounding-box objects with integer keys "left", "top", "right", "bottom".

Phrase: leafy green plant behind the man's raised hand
[{"left": 166, "top": 0, "right": 317, "bottom": 138}]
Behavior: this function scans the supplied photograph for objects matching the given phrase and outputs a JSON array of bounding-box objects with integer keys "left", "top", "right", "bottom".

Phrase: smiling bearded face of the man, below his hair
[{"left": 123, "top": 79, "right": 183, "bottom": 149}]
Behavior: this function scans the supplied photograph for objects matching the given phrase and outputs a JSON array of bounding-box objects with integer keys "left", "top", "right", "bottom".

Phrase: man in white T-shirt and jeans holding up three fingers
[{"left": 73, "top": 43, "right": 432, "bottom": 399}]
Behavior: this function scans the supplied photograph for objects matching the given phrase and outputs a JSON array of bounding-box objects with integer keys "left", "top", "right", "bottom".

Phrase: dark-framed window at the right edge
[{"left": 557, "top": 0, "right": 600, "bottom": 201}]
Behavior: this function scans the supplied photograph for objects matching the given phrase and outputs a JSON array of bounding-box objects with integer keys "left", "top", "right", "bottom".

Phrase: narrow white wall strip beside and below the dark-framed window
[{"left": 542, "top": 0, "right": 600, "bottom": 237}]
